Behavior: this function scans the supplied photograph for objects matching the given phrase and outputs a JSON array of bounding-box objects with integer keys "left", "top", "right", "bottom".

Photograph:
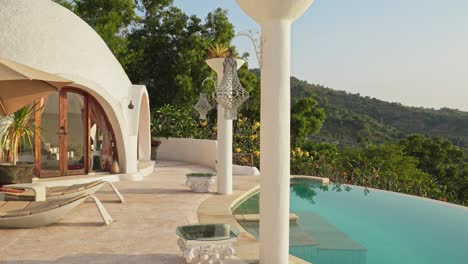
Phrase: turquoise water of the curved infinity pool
[{"left": 234, "top": 181, "right": 468, "bottom": 264}]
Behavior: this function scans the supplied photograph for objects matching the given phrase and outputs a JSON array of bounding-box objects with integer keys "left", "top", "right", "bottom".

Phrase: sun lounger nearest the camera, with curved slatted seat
[{"left": 0, "top": 195, "right": 113, "bottom": 228}]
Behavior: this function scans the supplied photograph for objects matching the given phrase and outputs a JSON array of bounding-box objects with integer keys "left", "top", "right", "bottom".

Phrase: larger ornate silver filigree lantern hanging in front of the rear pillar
[{"left": 214, "top": 57, "right": 249, "bottom": 120}]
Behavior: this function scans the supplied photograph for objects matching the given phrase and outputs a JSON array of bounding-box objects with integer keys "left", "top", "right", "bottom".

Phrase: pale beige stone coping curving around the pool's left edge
[{"left": 198, "top": 175, "right": 330, "bottom": 264}]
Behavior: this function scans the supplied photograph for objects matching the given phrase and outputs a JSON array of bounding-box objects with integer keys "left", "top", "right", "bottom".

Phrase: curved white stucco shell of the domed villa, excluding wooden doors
[{"left": 0, "top": 0, "right": 149, "bottom": 172}]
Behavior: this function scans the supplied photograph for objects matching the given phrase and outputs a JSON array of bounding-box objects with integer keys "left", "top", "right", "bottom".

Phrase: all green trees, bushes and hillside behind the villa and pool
[{"left": 56, "top": 0, "right": 468, "bottom": 205}]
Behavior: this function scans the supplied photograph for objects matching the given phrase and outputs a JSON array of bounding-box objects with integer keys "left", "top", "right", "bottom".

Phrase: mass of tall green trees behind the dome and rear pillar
[{"left": 56, "top": 0, "right": 259, "bottom": 116}]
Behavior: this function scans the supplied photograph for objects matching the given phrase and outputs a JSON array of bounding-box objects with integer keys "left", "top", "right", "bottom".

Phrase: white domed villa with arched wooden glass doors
[{"left": 0, "top": 0, "right": 153, "bottom": 178}]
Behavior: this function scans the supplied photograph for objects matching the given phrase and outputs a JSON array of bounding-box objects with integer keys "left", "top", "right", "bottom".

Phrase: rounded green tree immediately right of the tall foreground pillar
[{"left": 291, "top": 96, "right": 325, "bottom": 146}]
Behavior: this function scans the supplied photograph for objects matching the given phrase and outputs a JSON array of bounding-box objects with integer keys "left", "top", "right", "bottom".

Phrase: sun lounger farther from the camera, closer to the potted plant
[{"left": 0, "top": 180, "right": 125, "bottom": 203}]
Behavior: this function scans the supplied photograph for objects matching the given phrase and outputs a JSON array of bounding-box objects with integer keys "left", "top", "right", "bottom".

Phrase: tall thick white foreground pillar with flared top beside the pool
[{"left": 237, "top": 0, "right": 312, "bottom": 264}]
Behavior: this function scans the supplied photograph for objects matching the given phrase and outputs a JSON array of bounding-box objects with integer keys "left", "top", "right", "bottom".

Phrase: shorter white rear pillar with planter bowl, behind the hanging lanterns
[{"left": 206, "top": 58, "right": 245, "bottom": 195}]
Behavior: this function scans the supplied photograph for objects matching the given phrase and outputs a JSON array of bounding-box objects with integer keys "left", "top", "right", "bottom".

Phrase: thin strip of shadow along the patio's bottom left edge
[{"left": 0, "top": 254, "right": 185, "bottom": 264}]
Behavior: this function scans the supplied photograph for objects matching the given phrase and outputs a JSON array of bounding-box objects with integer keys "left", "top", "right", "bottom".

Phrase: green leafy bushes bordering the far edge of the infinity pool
[{"left": 291, "top": 144, "right": 454, "bottom": 201}]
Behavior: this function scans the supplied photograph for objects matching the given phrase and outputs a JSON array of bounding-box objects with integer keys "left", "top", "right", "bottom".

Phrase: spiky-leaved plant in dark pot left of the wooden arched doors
[{"left": 0, "top": 105, "right": 39, "bottom": 185}]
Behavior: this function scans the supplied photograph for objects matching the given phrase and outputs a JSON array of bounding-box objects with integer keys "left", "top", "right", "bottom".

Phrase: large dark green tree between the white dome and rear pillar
[{"left": 127, "top": 6, "right": 211, "bottom": 107}]
